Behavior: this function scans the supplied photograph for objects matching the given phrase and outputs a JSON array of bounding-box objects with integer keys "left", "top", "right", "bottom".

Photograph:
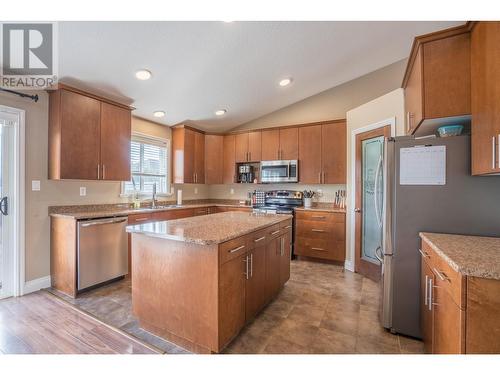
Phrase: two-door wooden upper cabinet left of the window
[{"left": 48, "top": 85, "right": 132, "bottom": 181}]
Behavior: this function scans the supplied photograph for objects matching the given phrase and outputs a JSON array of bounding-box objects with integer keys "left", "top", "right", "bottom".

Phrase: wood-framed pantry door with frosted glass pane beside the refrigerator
[{"left": 354, "top": 126, "right": 390, "bottom": 281}]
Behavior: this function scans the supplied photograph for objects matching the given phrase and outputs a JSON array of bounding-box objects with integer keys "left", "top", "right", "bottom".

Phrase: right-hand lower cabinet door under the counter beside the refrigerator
[{"left": 432, "top": 277, "right": 465, "bottom": 354}]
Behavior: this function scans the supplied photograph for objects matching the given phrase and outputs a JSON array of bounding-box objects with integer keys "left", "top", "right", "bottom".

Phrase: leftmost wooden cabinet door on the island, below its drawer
[{"left": 219, "top": 254, "right": 246, "bottom": 347}]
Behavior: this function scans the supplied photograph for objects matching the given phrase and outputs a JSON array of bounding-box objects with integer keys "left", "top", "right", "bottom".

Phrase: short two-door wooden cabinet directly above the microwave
[{"left": 262, "top": 127, "right": 299, "bottom": 160}]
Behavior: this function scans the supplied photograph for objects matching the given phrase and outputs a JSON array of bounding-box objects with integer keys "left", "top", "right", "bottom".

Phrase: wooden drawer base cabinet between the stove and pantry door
[{"left": 295, "top": 210, "right": 345, "bottom": 262}]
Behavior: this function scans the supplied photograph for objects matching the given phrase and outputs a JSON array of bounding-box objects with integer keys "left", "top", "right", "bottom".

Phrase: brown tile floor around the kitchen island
[{"left": 49, "top": 261, "right": 423, "bottom": 354}]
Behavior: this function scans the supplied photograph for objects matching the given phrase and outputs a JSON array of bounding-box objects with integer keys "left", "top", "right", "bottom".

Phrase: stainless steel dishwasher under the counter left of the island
[{"left": 77, "top": 216, "right": 128, "bottom": 290}]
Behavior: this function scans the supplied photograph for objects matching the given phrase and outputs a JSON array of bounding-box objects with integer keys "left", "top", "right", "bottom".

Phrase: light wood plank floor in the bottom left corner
[{"left": 0, "top": 291, "right": 162, "bottom": 354}]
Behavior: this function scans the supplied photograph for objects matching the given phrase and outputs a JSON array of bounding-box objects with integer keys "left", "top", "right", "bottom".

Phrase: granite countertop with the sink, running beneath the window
[{"left": 49, "top": 199, "right": 251, "bottom": 220}]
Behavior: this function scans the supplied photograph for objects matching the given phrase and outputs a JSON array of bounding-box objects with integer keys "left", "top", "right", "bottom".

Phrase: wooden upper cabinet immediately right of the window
[{"left": 172, "top": 126, "right": 205, "bottom": 184}]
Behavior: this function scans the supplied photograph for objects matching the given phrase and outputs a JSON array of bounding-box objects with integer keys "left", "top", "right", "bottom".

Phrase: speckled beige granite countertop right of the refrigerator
[{"left": 420, "top": 232, "right": 500, "bottom": 280}]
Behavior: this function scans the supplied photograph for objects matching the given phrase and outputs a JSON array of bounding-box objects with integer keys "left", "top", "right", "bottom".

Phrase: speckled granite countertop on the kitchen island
[{"left": 127, "top": 212, "right": 292, "bottom": 245}]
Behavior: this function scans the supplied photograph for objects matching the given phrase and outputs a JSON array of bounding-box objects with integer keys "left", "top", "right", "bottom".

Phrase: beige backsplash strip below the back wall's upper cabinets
[{"left": 207, "top": 184, "right": 346, "bottom": 202}]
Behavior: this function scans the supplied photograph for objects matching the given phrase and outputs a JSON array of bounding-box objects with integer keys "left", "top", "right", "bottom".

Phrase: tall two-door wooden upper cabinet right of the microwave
[{"left": 298, "top": 120, "right": 347, "bottom": 184}]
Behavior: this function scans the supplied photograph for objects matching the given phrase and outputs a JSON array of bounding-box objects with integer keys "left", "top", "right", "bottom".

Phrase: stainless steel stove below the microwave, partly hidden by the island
[{"left": 253, "top": 190, "right": 304, "bottom": 258}]
